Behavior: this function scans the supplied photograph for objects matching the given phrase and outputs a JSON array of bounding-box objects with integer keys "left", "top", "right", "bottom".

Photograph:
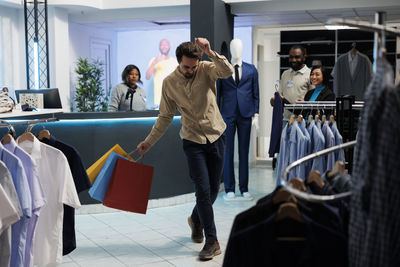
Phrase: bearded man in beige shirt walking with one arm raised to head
[{"left": 137, "top": 38, "right": 233, "bottom": 260}]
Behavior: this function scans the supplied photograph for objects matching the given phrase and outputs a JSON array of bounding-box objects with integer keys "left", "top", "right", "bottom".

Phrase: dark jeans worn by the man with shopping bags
[{"left": 183, "top": 135, "right": 225, "bottom": 240}]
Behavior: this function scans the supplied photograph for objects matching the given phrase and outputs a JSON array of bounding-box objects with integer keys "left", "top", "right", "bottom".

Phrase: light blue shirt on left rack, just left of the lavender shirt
[{"left": 0, "top": 143, "right": 32, "bottom": 267}]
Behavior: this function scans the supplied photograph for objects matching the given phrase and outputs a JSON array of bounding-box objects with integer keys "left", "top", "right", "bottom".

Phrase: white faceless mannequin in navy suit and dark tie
[{"left": 217, "top": 39, "right": 259, "bottom": 200}]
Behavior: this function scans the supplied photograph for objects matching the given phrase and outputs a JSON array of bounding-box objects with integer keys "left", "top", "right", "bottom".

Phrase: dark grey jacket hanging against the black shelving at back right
[{"left": 332, "top": 52, "right": 372, "bottom": 100}]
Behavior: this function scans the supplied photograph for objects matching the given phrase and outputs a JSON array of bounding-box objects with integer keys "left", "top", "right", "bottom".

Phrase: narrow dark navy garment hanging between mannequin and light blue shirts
[{"left": 268, "top": 92, "right": 283, "bottom": 158}]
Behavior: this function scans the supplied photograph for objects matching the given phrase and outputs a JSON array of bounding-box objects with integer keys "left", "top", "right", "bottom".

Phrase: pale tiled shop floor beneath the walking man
[{"left": 61, "top": 167, "right": 275, "bottom": 267}]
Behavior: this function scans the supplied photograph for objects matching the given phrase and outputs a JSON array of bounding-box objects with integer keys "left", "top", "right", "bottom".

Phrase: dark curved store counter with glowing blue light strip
[{"left": 3, "top": 111, "right": 194, "bottom": 204}]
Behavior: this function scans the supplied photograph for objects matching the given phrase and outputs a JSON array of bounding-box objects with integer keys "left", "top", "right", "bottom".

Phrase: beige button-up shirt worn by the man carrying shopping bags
[{"left": 145, "top": 53, "right": 233, "bottom": 145}]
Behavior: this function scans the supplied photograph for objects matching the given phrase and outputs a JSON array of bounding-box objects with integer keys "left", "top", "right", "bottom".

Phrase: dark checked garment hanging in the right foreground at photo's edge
[{"left": 349, "top": 60, "right": 400, "bottom": 267}]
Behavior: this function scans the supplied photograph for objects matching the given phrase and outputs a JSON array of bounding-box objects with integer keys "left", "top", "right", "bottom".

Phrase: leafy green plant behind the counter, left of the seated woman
[{"left": 75, "top": 57, "right": 108, "bottom": 112}]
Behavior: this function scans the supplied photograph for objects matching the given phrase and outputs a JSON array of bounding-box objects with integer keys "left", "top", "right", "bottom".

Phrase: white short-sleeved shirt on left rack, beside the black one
[{"left": 17, "top": 138, "right": 81, "bottom": 266}]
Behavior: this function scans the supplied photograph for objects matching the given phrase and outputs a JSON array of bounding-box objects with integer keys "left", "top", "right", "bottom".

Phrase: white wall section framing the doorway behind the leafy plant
[{"left": 67, "top": 22, "right": 120, "bottom": 110}]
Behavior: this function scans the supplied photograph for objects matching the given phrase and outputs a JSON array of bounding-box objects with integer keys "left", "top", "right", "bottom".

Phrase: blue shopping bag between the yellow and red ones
[{"left": 89, "top": 152, "right": 126, "bottom": 202}]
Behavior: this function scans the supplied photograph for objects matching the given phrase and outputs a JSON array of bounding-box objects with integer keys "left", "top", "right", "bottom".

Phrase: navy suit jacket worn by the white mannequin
[{"left": 217, "top": 62, "right": 259, "bottom": 118}]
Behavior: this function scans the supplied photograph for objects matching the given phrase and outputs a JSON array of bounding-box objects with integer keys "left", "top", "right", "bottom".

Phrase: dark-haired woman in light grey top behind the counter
[{"left": 108, "top": 65, "right": 146, "bottom": 112}]
